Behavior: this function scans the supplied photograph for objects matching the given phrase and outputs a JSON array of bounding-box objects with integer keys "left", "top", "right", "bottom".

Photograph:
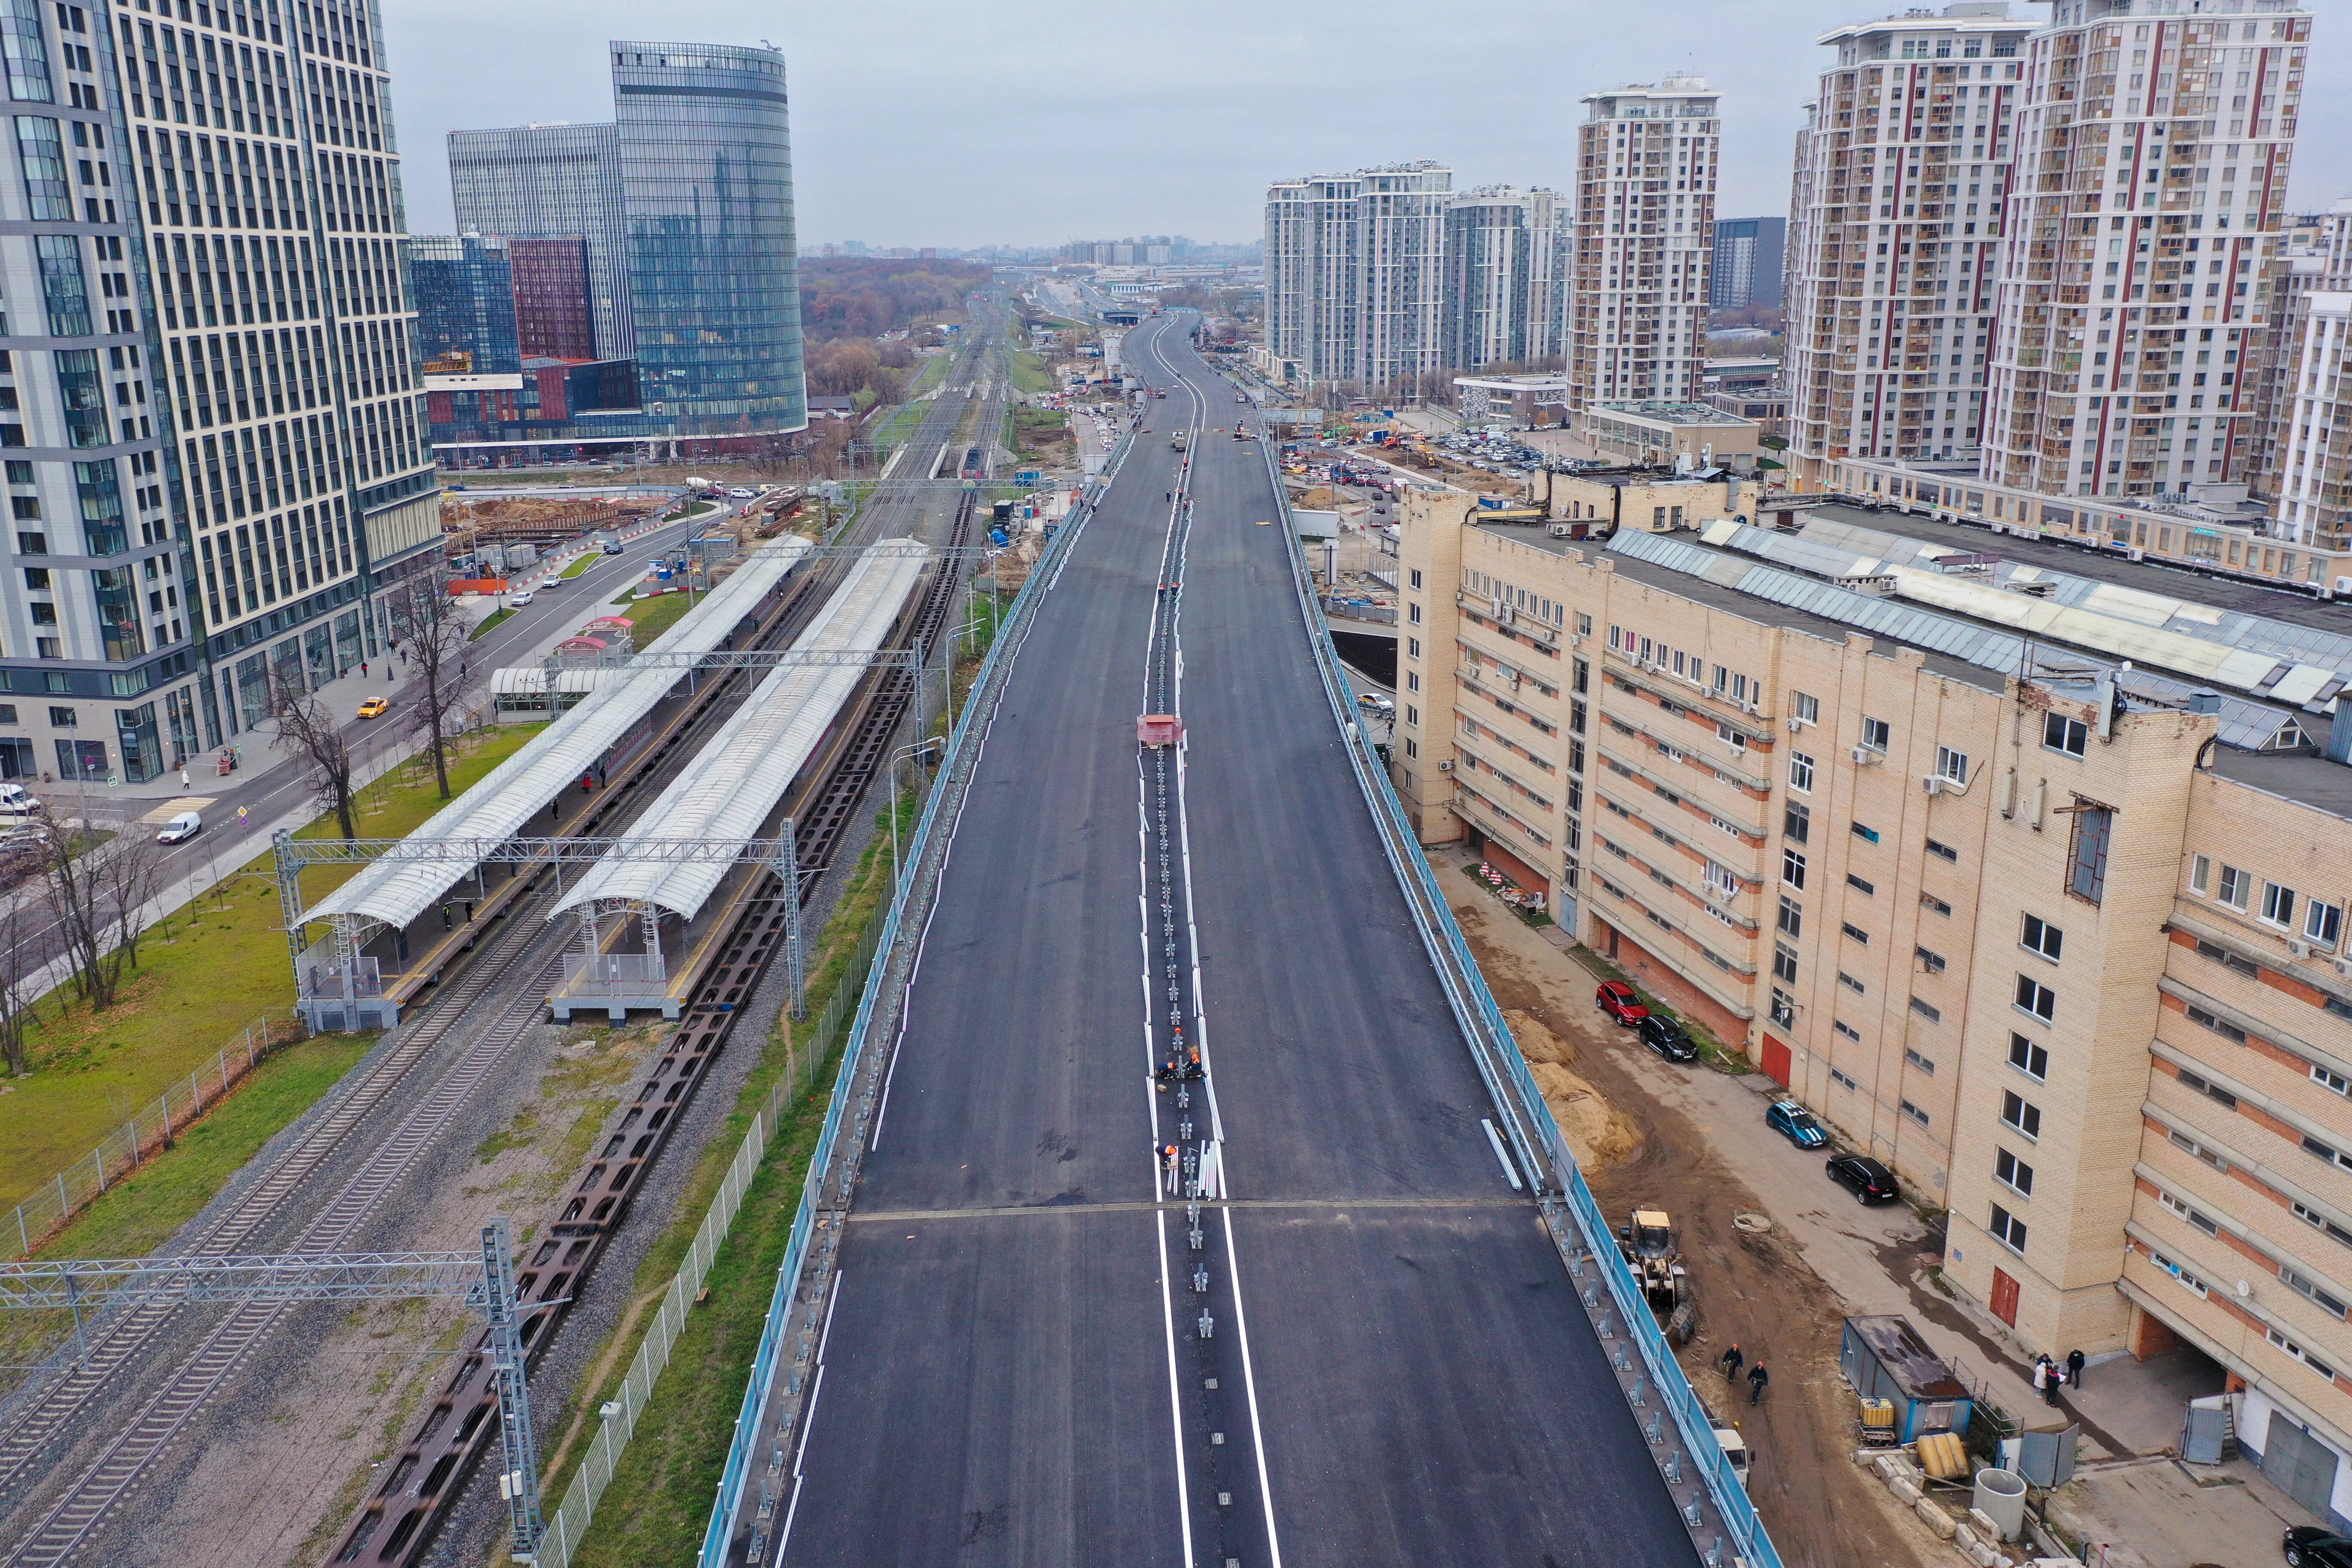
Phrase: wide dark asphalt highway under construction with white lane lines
[{"left": 734, "top": 315, "right": 1696, "bottom": 1568}]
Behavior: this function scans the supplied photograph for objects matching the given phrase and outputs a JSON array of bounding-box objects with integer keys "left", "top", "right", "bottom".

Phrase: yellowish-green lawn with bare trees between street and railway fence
[{"left": 0, "top": 724, "right": 541, "bottom": 1206}]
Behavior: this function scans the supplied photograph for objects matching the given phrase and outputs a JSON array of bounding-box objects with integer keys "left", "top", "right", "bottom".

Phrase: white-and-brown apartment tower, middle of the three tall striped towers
[{"left": 1785, "top": 0, "right": 2034, "bottom": 470}]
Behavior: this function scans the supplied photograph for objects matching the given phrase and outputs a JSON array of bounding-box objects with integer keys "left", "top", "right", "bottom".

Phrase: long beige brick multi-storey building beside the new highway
[{"left": 1392, "top": 491, "right": 2352, "bottom": 1526}]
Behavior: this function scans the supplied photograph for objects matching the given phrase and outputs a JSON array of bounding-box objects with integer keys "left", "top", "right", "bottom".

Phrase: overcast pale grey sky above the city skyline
[{"left": 383, "top": 0, "right": 2352, "bottom": 247}]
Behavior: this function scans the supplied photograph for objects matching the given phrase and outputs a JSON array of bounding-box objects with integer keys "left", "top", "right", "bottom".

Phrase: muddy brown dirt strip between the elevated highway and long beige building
[{"left": 1432, "top": 884, "right": 1959, "bottom": 1568}]
